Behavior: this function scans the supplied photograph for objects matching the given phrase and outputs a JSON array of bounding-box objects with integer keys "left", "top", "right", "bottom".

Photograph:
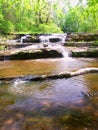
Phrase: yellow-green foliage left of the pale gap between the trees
[{"left": 0, "top": 0, "right": 61, "bottom": 33}]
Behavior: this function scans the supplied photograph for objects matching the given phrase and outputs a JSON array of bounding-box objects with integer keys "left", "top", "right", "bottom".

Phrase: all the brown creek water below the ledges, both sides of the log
[{"left": 0, "top": 57, "right": 98, "bottom": 130}]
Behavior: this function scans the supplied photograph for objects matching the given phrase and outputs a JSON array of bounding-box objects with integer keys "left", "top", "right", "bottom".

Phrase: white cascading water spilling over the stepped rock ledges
[{"left": 21, "top": 33, "right": 69, "bottom": 58}]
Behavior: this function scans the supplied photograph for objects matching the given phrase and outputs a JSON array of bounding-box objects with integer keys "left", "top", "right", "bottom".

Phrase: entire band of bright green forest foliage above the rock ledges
[{"left": 0, "top": 0, "right": 98, "bottom": 33}]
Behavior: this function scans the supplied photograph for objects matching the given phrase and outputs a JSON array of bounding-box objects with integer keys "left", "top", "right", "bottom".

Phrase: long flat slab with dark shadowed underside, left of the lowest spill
[{"left": 0, "top": 45, "right": 63, "bottom": 61}]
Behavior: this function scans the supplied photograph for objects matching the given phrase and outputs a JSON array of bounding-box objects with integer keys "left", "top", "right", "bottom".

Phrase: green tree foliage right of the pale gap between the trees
[{"left": 61, "top": 0, "right": 98, "bottom": 32}]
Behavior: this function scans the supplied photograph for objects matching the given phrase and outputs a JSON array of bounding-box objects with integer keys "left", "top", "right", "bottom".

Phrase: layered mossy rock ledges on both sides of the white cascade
[{"left": 0, "top": 33, "right": 98, "bottom": 60}]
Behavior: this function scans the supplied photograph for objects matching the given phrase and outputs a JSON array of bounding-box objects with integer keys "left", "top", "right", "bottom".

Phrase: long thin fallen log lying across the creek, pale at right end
[{"left": 0, "top": 68, "right": 98, "bottom": 82}]
